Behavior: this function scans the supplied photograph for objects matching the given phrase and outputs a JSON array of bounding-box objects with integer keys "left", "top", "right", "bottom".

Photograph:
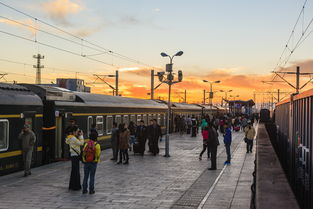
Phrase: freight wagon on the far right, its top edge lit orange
[{"left": 275, "top": 89, "right": 313, "bottom": 209}]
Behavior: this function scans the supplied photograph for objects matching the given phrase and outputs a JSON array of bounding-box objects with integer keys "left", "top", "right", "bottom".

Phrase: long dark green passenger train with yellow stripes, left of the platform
[{"left": 0, "top": 83, "right": 224, "bottom": 175}]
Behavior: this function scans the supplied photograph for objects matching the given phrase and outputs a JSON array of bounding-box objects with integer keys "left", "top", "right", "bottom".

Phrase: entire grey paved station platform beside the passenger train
[{"left": 0, "top": 132, "right": 255, "bottom": 209}]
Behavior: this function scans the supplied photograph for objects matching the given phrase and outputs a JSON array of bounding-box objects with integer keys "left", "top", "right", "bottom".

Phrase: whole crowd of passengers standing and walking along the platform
[{"left": 19, "top": 112, "right": 258, "bottom": 194}]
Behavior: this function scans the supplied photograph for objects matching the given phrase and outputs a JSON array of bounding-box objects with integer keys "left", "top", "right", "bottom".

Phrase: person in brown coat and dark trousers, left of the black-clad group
[{"left": 117, "top": 123, "right": 130, "bottom": 164}]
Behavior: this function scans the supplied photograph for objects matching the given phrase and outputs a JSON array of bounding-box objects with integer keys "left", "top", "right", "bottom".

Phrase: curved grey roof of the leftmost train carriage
[{"left": 0, "top": 83, "right": 42, "bottom": 106}]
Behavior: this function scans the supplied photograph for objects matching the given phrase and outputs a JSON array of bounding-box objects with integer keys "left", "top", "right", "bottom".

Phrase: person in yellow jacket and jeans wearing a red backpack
[{"left": 82, "top": 133, "right": 101, "bottom": 194}]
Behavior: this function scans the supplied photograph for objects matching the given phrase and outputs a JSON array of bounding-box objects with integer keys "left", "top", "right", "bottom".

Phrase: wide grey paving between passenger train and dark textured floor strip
[{"left": 0, "top": 132, "right": 217, "bottom": 209}]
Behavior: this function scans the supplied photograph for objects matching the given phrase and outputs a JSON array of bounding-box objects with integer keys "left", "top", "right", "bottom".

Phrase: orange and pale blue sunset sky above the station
[{"left": 0, "top": 0, "right": 313, "bottom": 103}]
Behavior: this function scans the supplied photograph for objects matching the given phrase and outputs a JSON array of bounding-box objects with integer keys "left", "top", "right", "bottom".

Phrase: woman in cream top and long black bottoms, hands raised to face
[{"left": 65, "top": 126, "right": 84, "bottom": 190}]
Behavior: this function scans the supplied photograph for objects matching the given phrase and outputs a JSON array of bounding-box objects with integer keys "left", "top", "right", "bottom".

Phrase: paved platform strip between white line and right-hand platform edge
[{"left": 202, "top": 135, "right": 255, "bottom": 209}]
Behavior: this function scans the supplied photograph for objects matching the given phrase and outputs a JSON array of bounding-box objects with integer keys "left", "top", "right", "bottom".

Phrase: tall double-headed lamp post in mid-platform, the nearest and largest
[{"left": 158, "top": 51, "right": 184, "bottom": 157}]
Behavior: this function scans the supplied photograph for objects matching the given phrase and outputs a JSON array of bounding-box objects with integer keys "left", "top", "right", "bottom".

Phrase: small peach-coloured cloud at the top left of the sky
[{"left": 42, "top": 0, "right": 83, "bottom": 25}]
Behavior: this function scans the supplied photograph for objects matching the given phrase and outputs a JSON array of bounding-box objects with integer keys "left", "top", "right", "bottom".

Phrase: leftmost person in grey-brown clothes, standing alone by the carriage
[{"left": 18, "top": 124, "right": 36, "bottom": 177}]
